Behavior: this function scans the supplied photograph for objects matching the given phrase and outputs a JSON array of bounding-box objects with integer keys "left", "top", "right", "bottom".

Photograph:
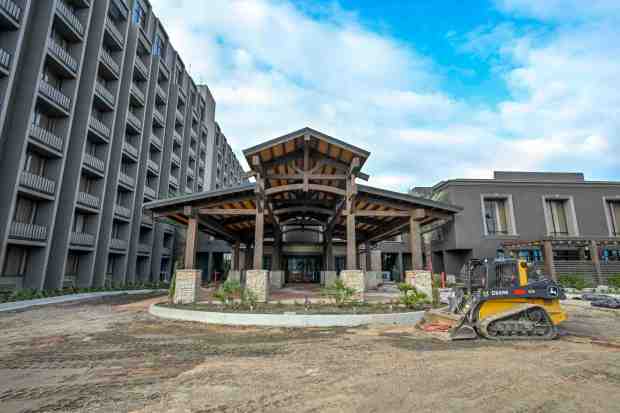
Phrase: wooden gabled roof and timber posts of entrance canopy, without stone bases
[{"left": 145, "top": 128, "right": 461, "bottom": 284}]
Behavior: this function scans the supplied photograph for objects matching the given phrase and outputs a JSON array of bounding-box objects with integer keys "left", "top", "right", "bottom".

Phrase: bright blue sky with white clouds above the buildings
[{"left": 151, "top": 0, "right": 620, "bottom": 191}]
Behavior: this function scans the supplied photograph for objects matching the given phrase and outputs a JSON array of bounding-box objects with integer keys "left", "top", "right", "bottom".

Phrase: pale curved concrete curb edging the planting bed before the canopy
[{"left": 149, "top": 304, "right": 424, "bottom": 327}]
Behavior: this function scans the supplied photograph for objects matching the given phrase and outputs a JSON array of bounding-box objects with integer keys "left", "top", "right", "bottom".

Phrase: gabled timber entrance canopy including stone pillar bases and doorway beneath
[{"left": 145, "top": 128, "right": 461, "bottom": 300}]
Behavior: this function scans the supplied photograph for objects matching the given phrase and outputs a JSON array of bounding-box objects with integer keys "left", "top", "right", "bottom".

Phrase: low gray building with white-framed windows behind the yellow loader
[{"left": 422, "top": 172, "right": 620, "bottom": 280}]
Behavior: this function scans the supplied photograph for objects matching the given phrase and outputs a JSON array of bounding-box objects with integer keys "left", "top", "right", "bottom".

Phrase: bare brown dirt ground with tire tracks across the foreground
[{"left": 0, "top": 297, "right": 620, "bottom": 413}]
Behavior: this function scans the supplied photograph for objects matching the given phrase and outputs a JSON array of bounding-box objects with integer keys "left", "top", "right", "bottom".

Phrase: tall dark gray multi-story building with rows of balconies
[{"left": 0, "top": 0, "right": 243, "bottom": 289}]
